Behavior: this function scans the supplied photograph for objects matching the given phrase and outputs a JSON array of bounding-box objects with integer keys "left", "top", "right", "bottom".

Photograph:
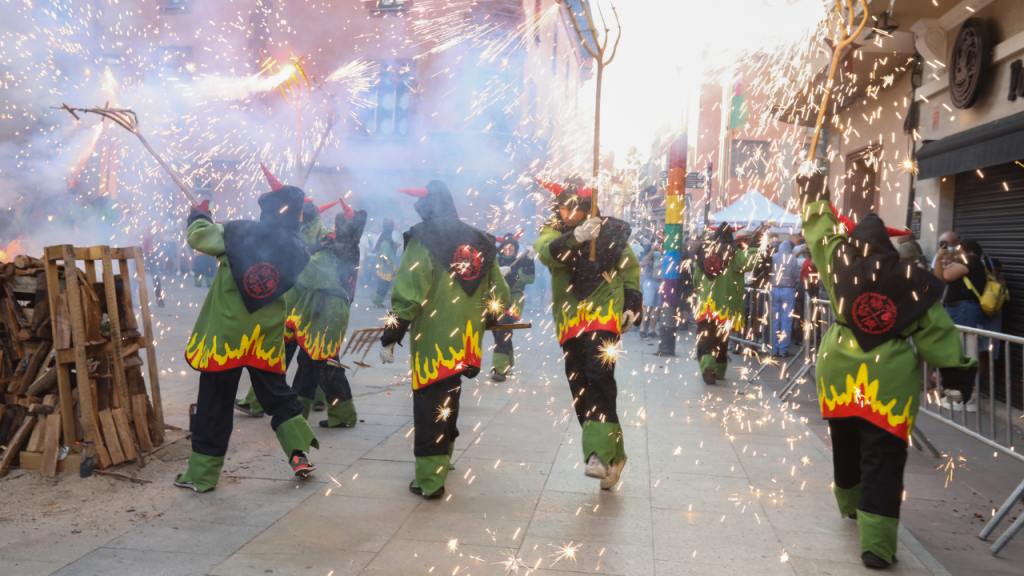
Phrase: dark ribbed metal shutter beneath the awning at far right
[{"left": 953, "top": 162, "right": 1024, "bottom": 408}]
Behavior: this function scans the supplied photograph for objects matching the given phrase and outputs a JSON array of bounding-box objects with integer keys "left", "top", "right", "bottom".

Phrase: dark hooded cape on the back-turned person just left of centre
[{"left": 403, "top": 180, "right": 498, "bottom": 296}]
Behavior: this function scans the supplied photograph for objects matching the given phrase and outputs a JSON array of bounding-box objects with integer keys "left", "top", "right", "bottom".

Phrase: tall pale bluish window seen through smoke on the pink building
[{"left": 353, "top": 59, "right": 416, "bottom": 137}]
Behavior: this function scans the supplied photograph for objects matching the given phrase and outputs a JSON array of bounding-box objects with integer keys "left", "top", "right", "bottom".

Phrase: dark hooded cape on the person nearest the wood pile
[{"left": 224, "top": 187, "right": 309, "bottom": 314}]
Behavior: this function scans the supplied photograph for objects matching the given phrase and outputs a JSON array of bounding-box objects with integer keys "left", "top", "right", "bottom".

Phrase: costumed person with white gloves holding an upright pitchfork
[{"left": 534, "top": 178, "right": 643, "bottom": 490}]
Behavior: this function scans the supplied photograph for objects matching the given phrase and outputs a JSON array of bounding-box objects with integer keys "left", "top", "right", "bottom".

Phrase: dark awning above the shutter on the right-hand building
[{"left": 918, "top": 112, "right": 1024, "bottom": 179}]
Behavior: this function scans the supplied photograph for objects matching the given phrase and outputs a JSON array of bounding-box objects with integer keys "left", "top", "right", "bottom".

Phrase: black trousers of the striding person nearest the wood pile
[{"left": 193, "top": 366, "right": 302, "bottom": 456}]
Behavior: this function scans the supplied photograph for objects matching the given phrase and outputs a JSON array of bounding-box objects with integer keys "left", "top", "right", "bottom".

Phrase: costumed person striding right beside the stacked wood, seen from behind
[{"left": 174, "top": 166, "right": 319, "bottom": 492}]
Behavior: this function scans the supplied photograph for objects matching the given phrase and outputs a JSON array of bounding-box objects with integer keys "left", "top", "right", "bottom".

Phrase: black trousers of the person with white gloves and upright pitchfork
[{"left": 562, "top": 330, "right": 618, "bottom": 425}]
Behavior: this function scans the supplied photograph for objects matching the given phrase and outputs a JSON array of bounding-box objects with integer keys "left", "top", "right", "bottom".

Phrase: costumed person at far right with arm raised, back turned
[{"left": 798, "top": 166, "right": 978, "bottom": 568}]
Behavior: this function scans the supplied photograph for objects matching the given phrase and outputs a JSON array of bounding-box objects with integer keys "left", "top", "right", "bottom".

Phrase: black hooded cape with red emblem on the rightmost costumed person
[{"left": 833, "top": 214, "right": 945, "bottom": 352}]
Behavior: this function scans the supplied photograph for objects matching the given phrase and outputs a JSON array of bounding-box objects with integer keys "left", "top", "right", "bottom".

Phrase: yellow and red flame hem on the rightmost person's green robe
[{"left": 818, "top": 363, "right": 914, "bottom": 440}]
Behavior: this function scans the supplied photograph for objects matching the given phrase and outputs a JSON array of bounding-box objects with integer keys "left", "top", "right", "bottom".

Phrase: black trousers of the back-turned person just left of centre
[{"left": 413, "top": 374, "right": 462, "bottom": 457}]
